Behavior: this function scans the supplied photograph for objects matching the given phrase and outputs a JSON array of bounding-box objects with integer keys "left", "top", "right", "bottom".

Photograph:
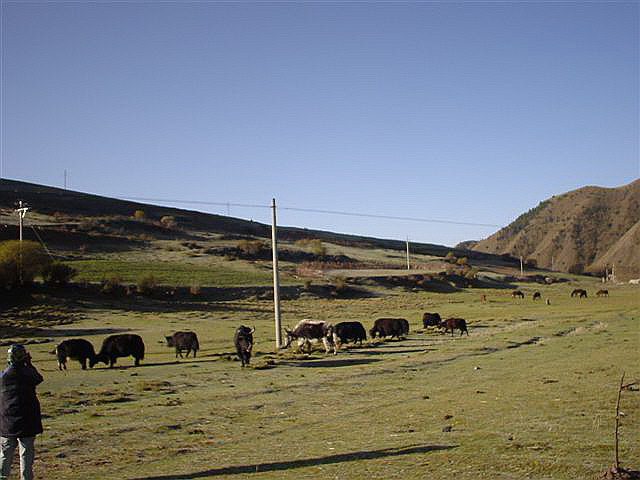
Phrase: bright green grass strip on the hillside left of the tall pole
[{"left": 68, "top": 260, "right": 294, "bottom": 287}]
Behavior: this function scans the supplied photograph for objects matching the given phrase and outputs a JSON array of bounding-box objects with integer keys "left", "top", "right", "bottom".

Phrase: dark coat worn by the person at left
[{"left": 0, "top": 364, "right": 42, "bottom": 438}]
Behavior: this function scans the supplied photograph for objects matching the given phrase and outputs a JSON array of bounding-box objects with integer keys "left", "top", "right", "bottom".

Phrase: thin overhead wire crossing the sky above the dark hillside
[{"left": 116, "top": 196, "right": 501, "bottom": 228}]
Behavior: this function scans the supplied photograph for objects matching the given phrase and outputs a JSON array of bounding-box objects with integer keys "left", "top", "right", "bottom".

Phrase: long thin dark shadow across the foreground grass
[{"left": 132, "top": 445, "right": 458, "bottom": 480}]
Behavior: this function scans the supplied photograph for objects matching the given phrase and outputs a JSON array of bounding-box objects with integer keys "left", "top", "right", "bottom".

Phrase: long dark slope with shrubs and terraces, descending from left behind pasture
[{"left": 0, "top": 180, "right": 518, "bottom": 287}]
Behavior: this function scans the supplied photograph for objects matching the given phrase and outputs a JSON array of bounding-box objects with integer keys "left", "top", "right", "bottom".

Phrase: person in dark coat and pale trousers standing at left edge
[{"left": 0, "top": 345, "right": 42, "bottom": 480}]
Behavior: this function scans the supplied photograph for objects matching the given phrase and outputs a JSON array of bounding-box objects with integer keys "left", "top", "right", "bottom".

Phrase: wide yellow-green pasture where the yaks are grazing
[{"left": 6, "top": 280, "right": 640, "bottom": 480}]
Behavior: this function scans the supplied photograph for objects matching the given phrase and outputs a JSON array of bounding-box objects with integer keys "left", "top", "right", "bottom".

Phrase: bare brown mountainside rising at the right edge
[{"left": 473, "top": 179, "right": 640, "bottom": 279}]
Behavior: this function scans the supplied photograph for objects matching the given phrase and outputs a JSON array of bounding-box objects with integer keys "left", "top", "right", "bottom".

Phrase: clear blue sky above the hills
[{"left": 1, "top": 0, "right": 640, "bottom": 245}]
